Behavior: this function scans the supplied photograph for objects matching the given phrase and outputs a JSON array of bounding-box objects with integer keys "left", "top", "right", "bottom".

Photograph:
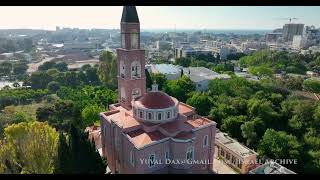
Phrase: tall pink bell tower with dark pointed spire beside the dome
[{"left": 117, "top": 6, "right": 146, "bottom": 109}]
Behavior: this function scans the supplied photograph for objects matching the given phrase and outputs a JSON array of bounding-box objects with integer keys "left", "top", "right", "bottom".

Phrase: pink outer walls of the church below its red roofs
[{"left": 101, "top": 112, "right": 215, "bottom": 174}]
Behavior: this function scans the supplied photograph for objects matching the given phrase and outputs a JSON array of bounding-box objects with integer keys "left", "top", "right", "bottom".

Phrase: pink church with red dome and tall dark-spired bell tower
[{"left": 100, "top": 6, "right": 216, "bottom": 174}]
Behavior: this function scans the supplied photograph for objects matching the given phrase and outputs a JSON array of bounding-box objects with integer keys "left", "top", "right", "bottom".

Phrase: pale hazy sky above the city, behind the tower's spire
[{"left": 0, "top": 6, "right": 320, "bottom": 30}]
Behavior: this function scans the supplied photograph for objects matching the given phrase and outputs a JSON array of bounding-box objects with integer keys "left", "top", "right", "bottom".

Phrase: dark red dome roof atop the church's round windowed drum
[{"left": 138, "top": 91, "right": 175, "bottom": 109}]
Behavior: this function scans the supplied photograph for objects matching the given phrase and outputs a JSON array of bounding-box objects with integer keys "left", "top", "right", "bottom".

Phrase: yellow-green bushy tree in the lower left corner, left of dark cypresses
[{"left": 0, "top": 121, "right": 58, "bottom": 174}]
